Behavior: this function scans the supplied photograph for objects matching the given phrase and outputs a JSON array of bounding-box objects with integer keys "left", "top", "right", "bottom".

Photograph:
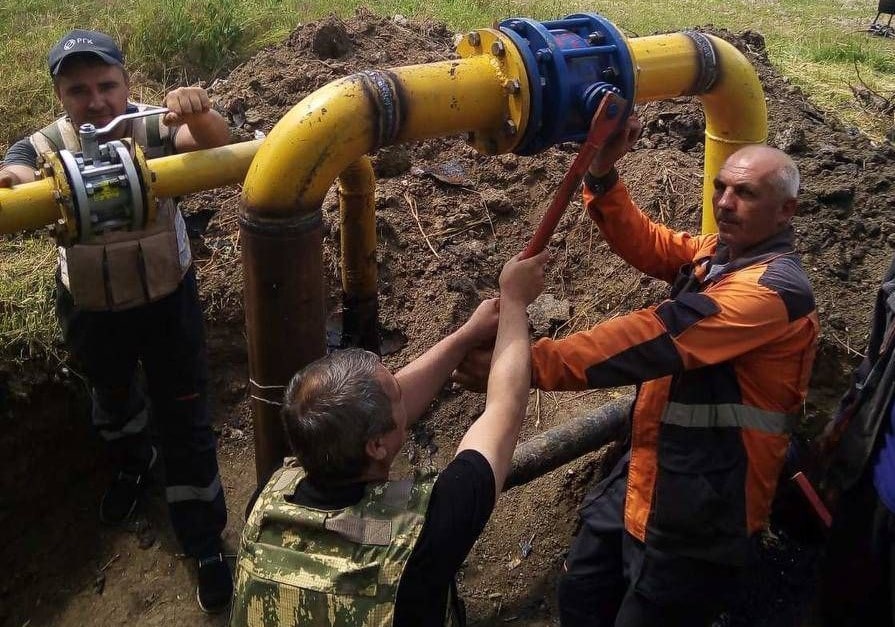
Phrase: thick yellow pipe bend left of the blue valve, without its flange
[{"left": 243, "top": 55, "right": 506, "bottom": 217}]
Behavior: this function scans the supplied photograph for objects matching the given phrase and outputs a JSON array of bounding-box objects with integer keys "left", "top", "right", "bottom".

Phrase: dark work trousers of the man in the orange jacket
[{"left": 559, "top": 455, "right": 742, "bottom": 627}]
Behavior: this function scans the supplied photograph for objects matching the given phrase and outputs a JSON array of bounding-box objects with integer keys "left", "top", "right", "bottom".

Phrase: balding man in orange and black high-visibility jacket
[{"left": 457, "top": 119, "right": 818, "bottom": 627}]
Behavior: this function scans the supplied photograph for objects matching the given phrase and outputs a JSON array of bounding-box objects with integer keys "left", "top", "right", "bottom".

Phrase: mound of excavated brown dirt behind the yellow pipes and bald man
[{"left": 198, "top": 11, "right": 895, "bottom": 364}]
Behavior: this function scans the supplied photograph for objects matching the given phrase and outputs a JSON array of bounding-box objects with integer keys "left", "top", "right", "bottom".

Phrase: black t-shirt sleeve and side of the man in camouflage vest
[{"left": 394, "top": 450, "right": 494, "bottom": 627}]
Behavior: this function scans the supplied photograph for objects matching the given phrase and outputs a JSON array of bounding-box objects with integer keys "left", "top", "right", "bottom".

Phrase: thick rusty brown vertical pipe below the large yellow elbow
[{"left": 239, "top": 212, "right": 326, "bottom": 486}]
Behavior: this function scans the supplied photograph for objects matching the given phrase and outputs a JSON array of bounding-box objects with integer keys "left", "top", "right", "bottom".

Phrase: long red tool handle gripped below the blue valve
[{"left": 522, "top": 92, "right": 627, "bottom": 259}]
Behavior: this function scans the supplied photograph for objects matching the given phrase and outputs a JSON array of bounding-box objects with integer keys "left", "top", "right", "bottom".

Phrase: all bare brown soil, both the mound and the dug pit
[{"left": 0, "top": 13, "right": 895, "bottom": 627}]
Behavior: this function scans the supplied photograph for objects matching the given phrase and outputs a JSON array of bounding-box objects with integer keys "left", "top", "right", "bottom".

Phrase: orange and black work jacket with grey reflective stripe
[{"left": 532, "top": 183, "right": 818, "bottom": 564}]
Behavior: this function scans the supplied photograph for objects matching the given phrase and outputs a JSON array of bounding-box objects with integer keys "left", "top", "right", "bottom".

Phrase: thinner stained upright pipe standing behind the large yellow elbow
[{"left": 339, "top": 156, "right": 379, "bottom": 354}]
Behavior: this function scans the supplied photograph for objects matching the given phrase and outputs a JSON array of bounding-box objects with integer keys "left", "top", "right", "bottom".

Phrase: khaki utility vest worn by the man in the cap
[{"left": 29, "top": 105, "right": 190, "bottom": 311}]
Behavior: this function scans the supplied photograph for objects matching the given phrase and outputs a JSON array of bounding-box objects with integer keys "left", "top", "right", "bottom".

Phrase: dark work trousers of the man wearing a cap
[{"left": 56, "top": 268, "right": 227, "bottom": 557}]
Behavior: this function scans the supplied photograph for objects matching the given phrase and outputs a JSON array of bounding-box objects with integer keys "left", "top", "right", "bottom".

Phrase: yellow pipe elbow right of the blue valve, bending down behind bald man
[{"left": 628, "top": 33, "right": 768, "bottom": 233}]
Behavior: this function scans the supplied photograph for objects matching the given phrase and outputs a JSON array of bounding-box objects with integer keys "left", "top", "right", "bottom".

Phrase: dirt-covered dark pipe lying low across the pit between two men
[{"left": 503, "top": 396, "right": 634, "bottom": 490}]
